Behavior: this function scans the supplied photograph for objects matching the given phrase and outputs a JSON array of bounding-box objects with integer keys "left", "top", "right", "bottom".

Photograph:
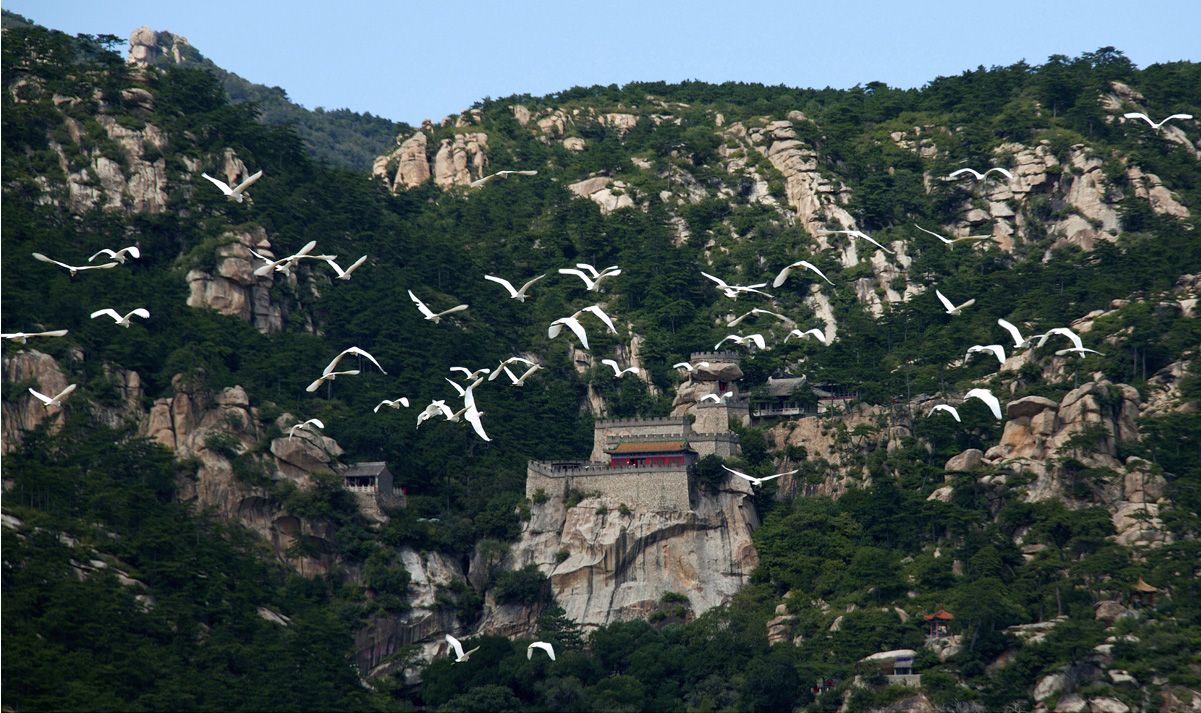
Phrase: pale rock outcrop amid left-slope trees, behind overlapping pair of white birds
[{"left": 187, "top": 227, "right": 283, "bottom": 334}]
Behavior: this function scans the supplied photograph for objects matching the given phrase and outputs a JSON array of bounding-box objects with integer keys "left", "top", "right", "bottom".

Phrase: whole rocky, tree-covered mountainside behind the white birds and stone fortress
[{"left": 0, "top": 18, "right": 1201, "bottom": 711}]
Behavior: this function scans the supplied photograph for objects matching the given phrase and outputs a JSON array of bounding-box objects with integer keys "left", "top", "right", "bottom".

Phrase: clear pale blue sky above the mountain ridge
[{"left": 4, "top": 0, "right": 1201, "bottom": 124}]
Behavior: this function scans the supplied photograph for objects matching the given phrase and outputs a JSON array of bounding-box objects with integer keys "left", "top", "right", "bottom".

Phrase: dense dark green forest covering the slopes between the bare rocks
[{"left": 0, "top": 13, "right": 1201, "bottom": 711}]
